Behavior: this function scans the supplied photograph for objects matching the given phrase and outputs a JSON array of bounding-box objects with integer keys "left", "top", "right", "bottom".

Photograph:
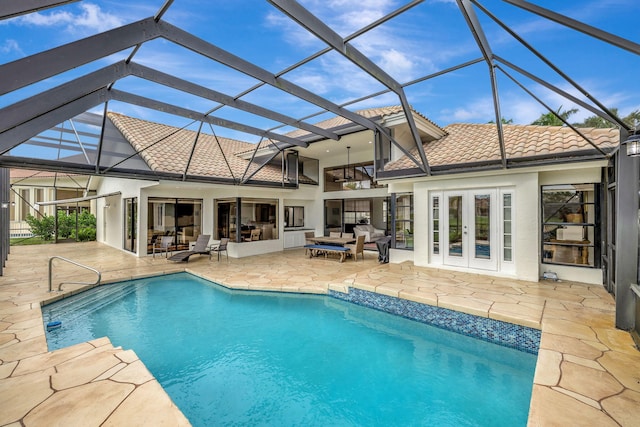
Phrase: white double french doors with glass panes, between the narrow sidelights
[{"left": 442, "top": 189, "right": 499, "bottom": 270}]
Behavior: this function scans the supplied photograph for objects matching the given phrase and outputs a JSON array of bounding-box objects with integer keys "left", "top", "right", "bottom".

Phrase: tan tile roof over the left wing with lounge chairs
[{"left": 108, "top": 113, "right": 282, "bottom": 182}]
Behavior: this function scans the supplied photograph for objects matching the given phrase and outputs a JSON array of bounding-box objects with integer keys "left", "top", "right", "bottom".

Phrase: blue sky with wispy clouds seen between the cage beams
[{"left": 0, "top": 0, "right": 640, "bottom": 145}]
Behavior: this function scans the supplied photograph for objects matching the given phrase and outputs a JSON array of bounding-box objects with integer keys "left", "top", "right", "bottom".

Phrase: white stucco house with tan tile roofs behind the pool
[{"left": 82, "top": 107, "right": 619, "bottom": 284}]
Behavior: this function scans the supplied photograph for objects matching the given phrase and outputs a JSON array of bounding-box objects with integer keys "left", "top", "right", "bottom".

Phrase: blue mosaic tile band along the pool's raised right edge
[{"left": 329, "top": 287, "right": 541, "bottom": 355}]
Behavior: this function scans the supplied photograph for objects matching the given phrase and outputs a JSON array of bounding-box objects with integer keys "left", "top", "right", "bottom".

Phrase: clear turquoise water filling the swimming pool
[{"left": 43, "top": 273, "right": 536, "bottom": 426}]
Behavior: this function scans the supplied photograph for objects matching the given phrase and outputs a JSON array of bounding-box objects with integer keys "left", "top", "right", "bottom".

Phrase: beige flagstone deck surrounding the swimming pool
[{"left": 0, "top": 242, "right": 640, "bottom": 427}]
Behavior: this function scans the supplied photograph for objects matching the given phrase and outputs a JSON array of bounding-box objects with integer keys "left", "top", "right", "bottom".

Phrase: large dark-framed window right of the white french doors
[{"left": 542, "top": 184, "right": 600, "bottom": 267}]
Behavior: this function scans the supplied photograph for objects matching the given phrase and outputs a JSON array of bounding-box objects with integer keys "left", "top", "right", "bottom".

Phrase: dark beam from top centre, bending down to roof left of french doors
[{"left": 268, "top": 0, "right": 430, "bottom": 175}]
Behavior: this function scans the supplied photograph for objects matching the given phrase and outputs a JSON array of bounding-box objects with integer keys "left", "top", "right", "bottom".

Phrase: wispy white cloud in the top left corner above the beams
[{"left": 14, "top": 3, "right": 123, "bottom": 33}]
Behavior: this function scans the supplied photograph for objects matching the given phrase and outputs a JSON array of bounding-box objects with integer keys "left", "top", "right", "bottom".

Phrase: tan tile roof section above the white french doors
[{"left": 385, "top": 124, "right": 620, "bottom": 170}]
